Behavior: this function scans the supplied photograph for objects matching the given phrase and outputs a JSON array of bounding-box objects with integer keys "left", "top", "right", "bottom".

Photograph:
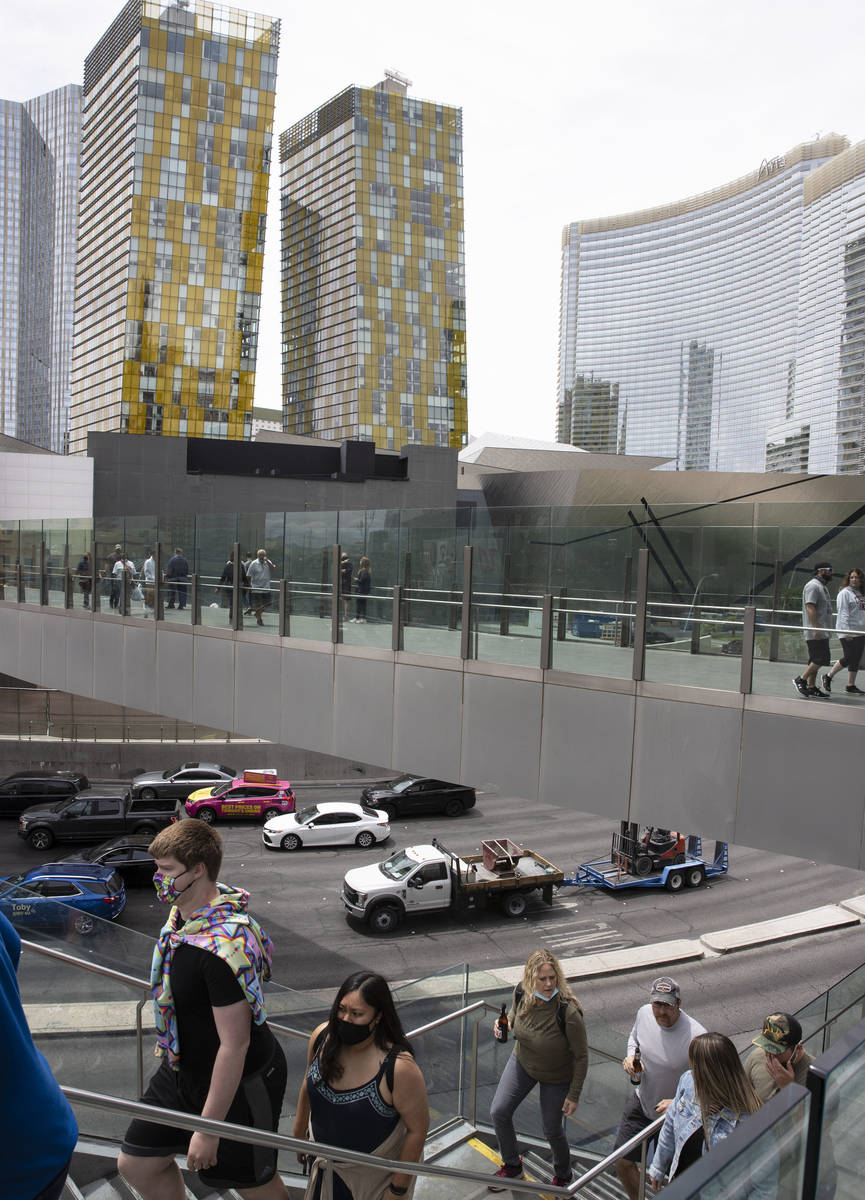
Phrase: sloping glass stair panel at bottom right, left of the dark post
[{"left": 663, "top": 1084, "right": 811, "bottom": 1200}]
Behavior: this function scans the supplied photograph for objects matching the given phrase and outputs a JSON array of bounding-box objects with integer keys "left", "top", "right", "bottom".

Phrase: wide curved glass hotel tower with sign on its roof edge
[{"left": 557, "top": 134, "right": 865, "bottom": 473}]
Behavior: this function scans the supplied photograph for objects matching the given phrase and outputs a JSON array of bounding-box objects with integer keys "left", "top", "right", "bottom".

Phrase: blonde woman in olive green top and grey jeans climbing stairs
[{"left": 489, "top": 950, "right": 589, "bottom": 1192}]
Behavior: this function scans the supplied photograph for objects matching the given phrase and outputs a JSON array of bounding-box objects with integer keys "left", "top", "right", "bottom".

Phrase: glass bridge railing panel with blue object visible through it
[{"left": 552, "top": 600, "right": 633, "bottom": 679}]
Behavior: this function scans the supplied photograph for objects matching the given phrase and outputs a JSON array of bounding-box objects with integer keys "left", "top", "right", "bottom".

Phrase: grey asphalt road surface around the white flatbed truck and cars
[{"left": 0, "top": 787, "right": 865, "bottom": 990}]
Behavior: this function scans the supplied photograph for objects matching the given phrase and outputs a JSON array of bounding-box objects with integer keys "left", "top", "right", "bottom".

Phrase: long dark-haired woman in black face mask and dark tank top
[{"left": 294, "top": 971, "right": 430, "bottom": 1200}]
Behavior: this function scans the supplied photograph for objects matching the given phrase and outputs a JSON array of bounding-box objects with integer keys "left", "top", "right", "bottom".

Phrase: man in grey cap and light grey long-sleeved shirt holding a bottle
[{"left": 615, "top": 976, "right": 705, "bottom": 1200}]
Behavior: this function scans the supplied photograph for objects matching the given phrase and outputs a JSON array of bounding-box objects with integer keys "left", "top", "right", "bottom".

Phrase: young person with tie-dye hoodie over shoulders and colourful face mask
[{"left": 119, "top": 820, "right": 288, "bottom": 1200}]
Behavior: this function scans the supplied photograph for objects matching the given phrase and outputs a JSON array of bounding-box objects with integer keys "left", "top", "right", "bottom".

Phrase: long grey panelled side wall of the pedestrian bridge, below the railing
[{"left": 0, "top": 602, "right": 865, "bottom": 869}]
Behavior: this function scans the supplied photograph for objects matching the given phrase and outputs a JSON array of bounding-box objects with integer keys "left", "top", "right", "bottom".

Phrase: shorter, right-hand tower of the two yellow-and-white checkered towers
[{"left": 280, "top": 72, "right": 468, "bottom": 450}]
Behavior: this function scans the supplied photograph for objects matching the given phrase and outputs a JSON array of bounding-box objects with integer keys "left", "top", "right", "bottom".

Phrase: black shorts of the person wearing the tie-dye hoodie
[{"left": 121, "top": 1043, "right": 288, "bottom": 1188}]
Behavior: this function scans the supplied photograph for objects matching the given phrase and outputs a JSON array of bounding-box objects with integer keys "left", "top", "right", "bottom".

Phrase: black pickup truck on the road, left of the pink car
[{"left": 18, "top": 784, "right": 178, "bottom": 850}]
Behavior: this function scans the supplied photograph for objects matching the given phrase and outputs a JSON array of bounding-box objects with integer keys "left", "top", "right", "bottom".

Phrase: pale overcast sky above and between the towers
[{"left": 6, "top": 0, "right": 865, "bottom": 438}]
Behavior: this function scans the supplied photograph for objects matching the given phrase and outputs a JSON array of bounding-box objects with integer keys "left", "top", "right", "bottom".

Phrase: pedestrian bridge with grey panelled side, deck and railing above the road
[{"left": 0, "top": 520, "right": 865, "bottom": 868}]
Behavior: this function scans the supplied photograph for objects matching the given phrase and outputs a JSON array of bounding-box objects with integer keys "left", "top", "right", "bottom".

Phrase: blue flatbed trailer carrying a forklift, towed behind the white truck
[{"left": 563, "top": 826, "right": 729, "bottom": 892}]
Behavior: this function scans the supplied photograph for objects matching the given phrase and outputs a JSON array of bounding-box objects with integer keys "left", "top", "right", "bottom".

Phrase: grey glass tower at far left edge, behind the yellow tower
[{"left": 0, "top": 84, "right": 80, "bottom": 454}]
